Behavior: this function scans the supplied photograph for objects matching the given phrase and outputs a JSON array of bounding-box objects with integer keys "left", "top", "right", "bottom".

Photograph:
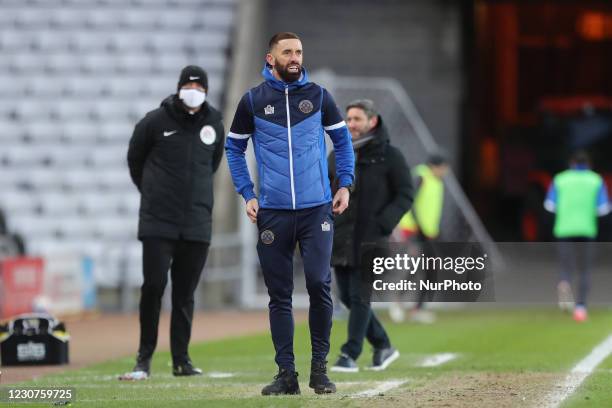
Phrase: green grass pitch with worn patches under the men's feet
[{"left": 7, "top": 308, "right": 612, "bottom": 408}]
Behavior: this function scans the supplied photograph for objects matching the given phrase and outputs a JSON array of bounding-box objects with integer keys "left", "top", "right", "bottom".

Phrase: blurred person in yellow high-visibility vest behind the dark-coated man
[{"left": 389, "top": 153, "right": 448, "bottom": 323}]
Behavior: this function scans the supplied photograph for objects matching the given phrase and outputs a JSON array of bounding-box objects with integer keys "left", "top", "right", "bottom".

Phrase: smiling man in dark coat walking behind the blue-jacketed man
[{"left": 328, "top": 99, "right": 413, "bottom": 372}]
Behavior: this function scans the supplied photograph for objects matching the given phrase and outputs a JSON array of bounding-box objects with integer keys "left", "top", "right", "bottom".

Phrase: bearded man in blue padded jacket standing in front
[{"left": 225, "top": 32, "right": 354, "bottom": 395}]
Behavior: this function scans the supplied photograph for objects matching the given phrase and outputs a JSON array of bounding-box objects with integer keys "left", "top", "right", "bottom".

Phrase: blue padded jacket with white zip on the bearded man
[{"left": 225, "top": 67, "right": 355, "bottom": 210}]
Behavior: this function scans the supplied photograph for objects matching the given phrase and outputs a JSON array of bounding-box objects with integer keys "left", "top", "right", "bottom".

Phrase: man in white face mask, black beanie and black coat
[{"left": 120, "top": 65, "right": 225, "bottom": 380}]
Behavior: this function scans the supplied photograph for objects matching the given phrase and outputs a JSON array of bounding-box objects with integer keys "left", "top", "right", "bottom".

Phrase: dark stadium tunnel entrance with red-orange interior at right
[{"left": 462, "top": 0, "right": 612, "bottom": 241}]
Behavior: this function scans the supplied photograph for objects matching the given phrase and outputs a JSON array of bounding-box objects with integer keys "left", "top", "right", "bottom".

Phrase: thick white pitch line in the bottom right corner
[{"left": 545, "top": 335, "right": 612, "bottom": 408}]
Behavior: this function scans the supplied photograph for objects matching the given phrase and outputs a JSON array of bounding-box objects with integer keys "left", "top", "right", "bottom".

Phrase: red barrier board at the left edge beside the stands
[{"left": 0, "top": 258, "right": 44, "bottom": 318}]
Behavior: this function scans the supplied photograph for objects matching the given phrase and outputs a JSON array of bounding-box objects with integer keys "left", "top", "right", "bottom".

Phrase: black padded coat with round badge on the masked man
[{"left": 127, "top": 95, "right": 225, "bottom": 242}]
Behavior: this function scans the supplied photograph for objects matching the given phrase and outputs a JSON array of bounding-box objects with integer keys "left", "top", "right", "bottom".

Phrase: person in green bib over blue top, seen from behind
[{"left": 544, "top": 151, "right": 610, "bottom": 322}]
